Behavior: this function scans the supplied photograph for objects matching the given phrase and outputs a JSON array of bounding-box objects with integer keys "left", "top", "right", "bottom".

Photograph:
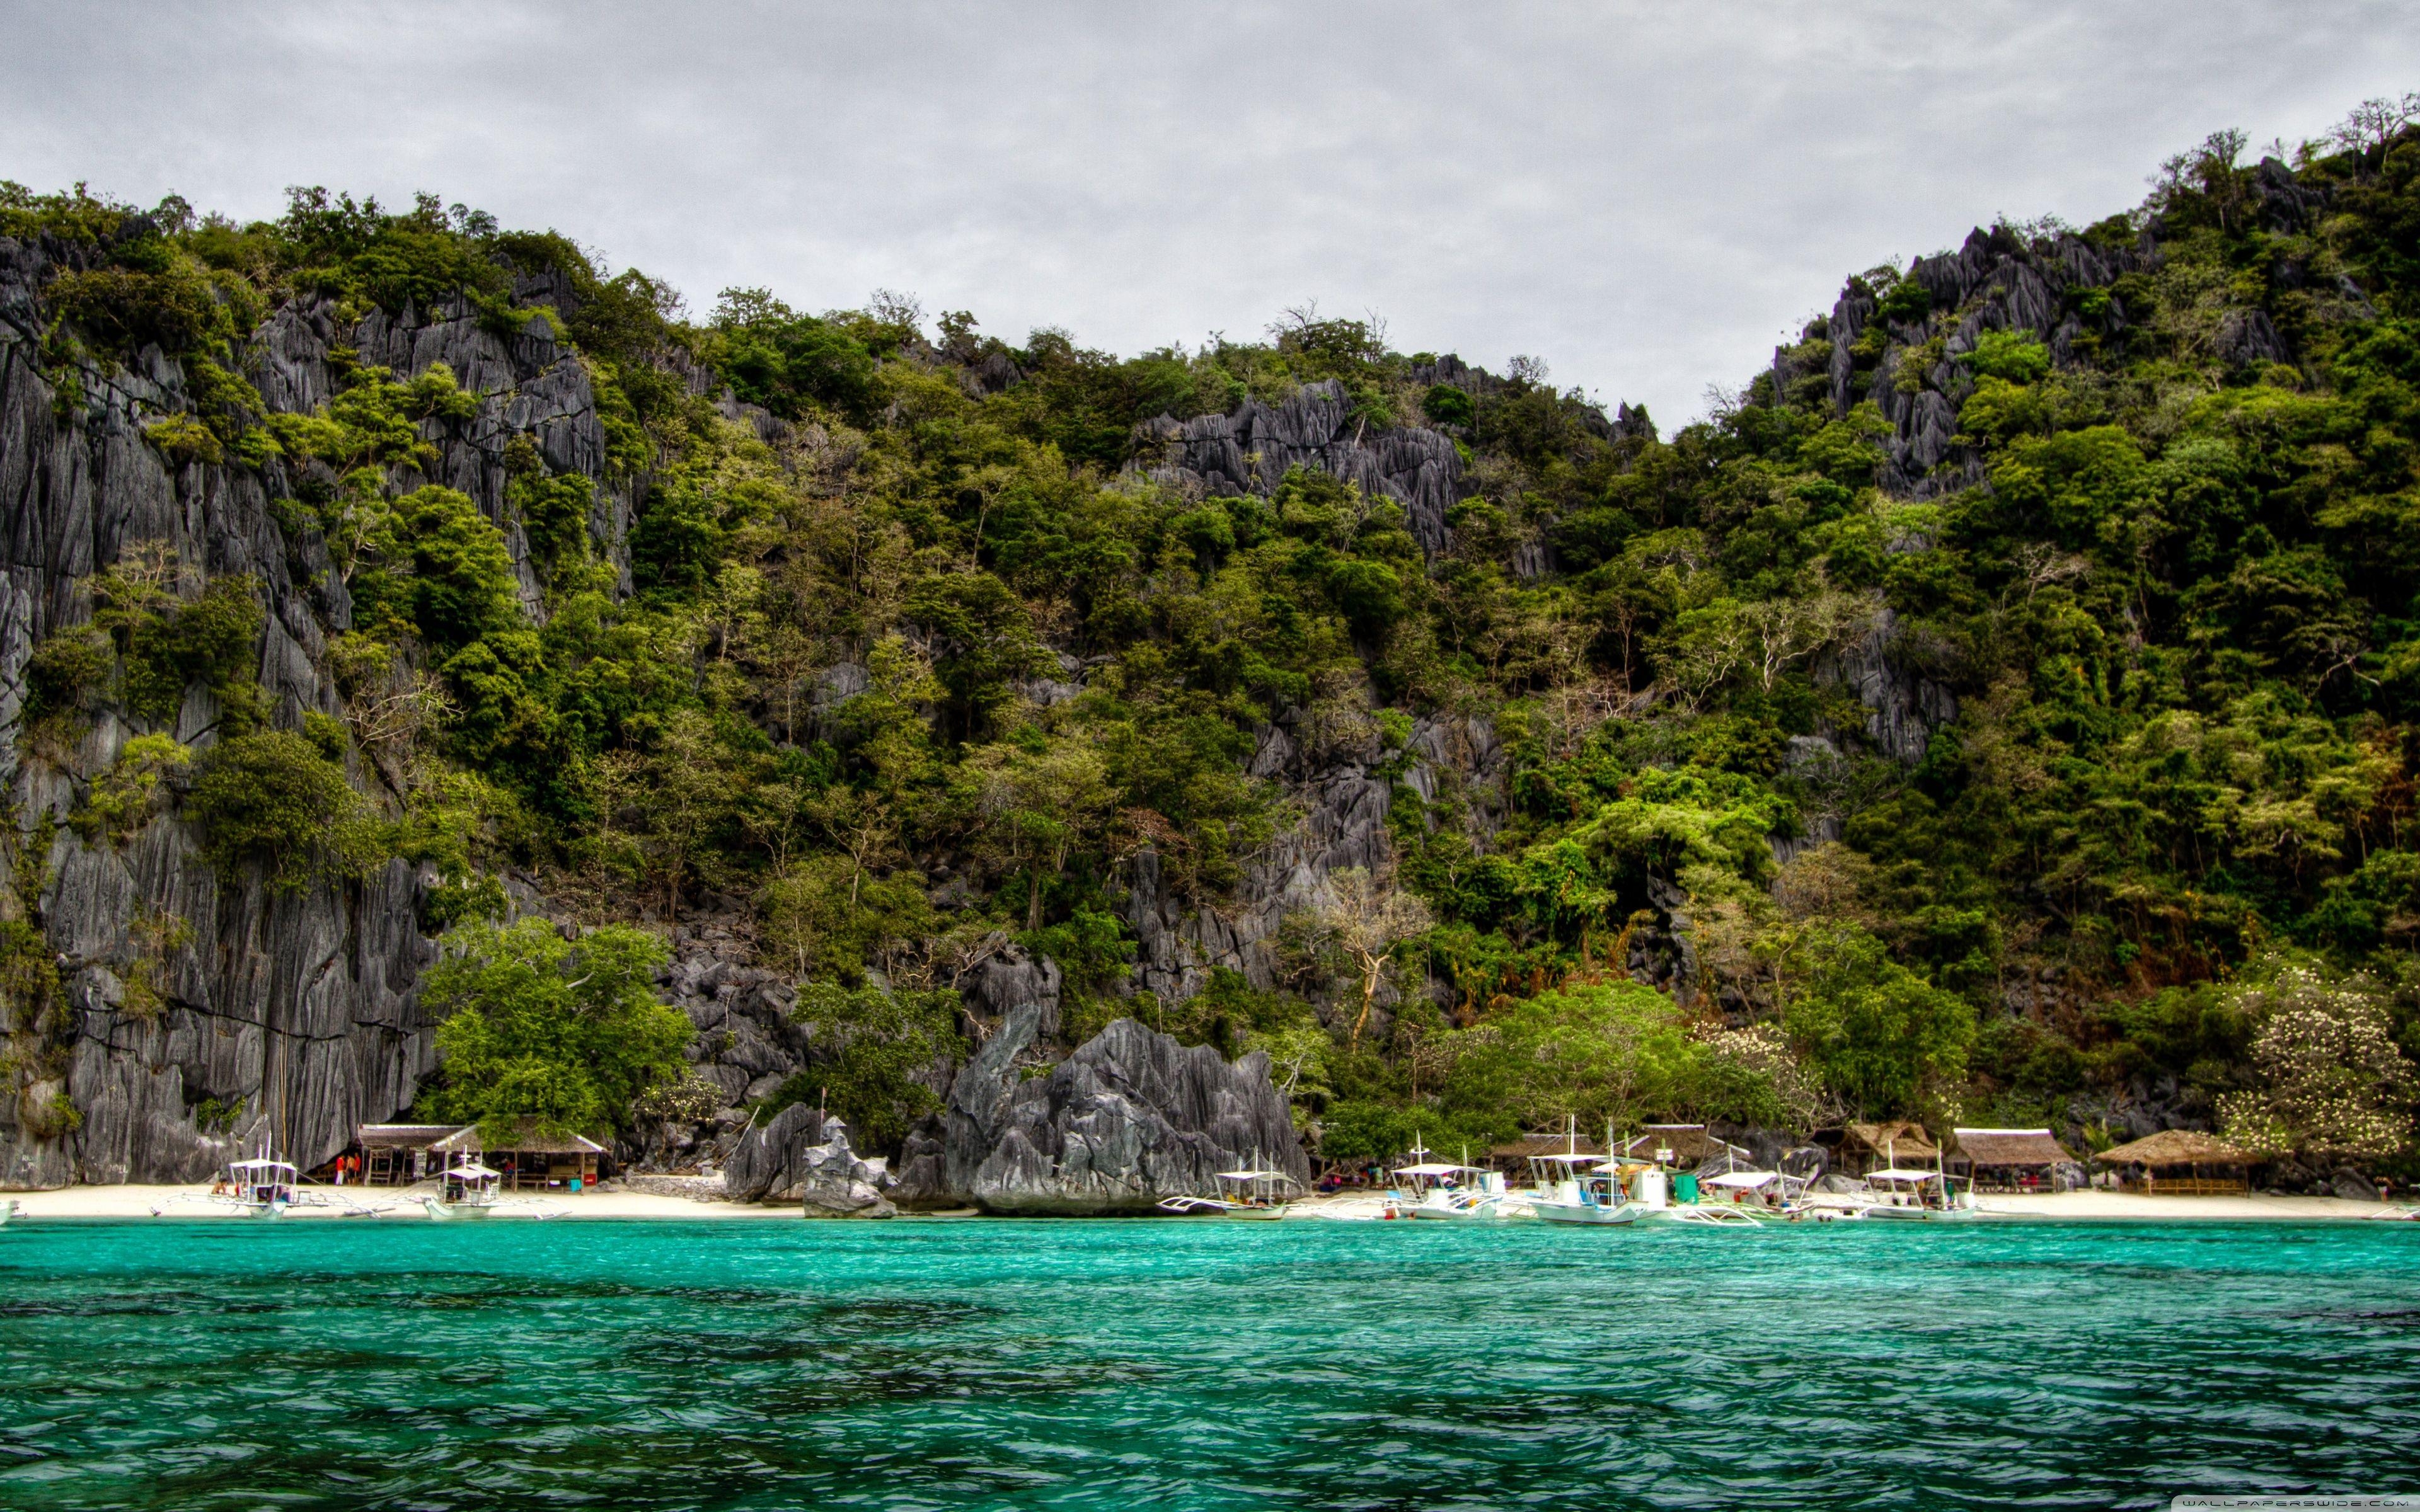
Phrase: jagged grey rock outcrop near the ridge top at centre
[{"left": 1140, "top": 380, "right": 1464, "bottom": 556}]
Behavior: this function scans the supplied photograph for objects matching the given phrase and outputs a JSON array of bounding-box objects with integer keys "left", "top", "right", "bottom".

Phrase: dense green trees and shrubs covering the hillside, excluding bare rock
[{"left": 0, "top": 94, "right": 2420, "bottom": 1164}]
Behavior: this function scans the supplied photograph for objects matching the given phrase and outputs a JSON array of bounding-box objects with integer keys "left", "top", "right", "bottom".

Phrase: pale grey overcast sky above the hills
[{"left": 0, "top": 0, "right": 2420, "bottom": 431}]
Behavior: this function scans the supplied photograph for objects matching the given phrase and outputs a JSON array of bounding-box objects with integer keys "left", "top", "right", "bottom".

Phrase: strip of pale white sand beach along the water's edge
[{"left": 0, "top": 1183, "right": 2411, "bottom": 1224}]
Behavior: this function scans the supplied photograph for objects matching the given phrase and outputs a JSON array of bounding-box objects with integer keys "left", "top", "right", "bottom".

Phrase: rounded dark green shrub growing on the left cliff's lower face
[{"left": 187, "top": 731, "right": 385, "bottom": 893}]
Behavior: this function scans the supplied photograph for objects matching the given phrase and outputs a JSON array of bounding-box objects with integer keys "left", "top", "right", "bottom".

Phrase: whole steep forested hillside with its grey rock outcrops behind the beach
[{"left": 0, "top": 101, "right": 2420, "bottom": 1181}]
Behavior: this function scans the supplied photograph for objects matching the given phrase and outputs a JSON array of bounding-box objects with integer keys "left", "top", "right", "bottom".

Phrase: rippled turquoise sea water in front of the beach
[{"left": 0, "top": 1219, "right": 2420, "bottom": 1512}]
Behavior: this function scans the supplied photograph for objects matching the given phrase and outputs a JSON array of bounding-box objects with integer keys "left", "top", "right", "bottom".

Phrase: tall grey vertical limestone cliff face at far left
[{"left": 0, "top": 227, "right": 629, "bottom": 1186}]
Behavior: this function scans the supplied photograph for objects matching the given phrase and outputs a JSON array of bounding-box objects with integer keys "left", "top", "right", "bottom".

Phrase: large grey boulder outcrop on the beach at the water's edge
[{"left": 896, "top": 1004, "right": 1309, "bottom": 1215}]
